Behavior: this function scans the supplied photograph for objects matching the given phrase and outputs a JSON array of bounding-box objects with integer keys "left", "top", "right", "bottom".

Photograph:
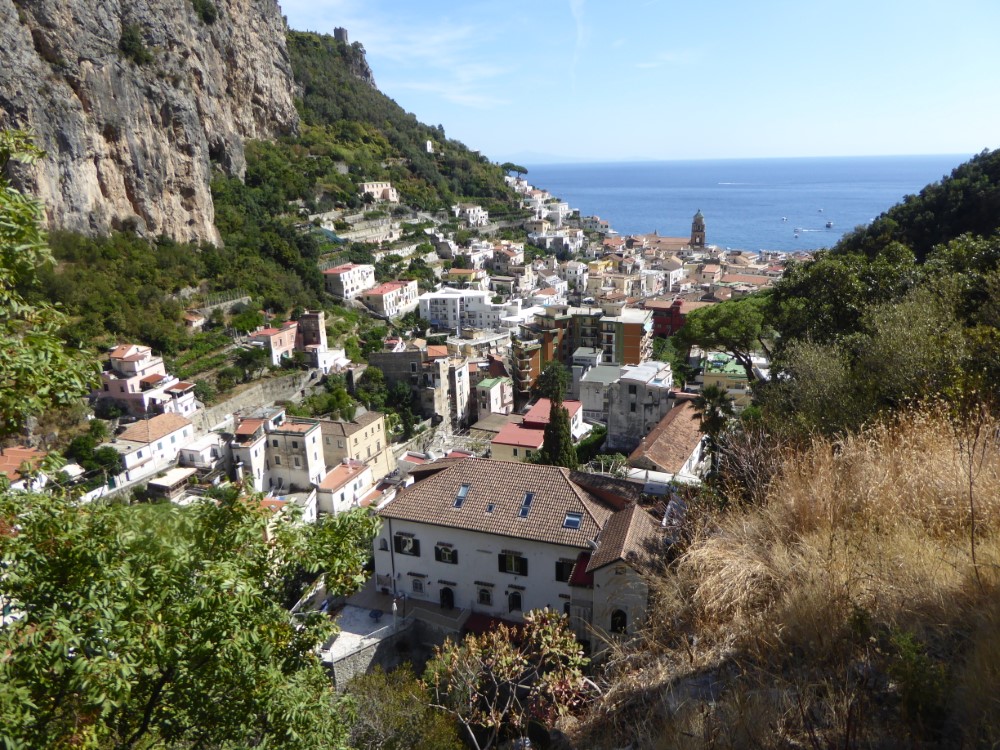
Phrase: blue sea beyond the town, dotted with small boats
[{"left": 525, "top": 154, "right": 971, "bottom": 252}]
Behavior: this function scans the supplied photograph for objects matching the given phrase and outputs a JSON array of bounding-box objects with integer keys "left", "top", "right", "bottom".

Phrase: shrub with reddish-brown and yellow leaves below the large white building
[{"left": 424, "top": 609, "right": 587, "bottom": 750}]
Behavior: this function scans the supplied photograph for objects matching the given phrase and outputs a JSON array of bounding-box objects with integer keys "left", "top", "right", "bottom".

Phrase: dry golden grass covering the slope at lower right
[{"left": 579, "top": 410, "right": 1000, "bottom": 750}]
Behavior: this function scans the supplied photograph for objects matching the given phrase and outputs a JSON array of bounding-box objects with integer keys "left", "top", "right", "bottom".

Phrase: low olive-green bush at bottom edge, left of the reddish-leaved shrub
[{"left": 347, "top": 664, "right": 465, "bottom": 750}]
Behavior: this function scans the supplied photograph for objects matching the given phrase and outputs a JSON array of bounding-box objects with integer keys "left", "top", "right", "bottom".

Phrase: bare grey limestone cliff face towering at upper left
[{"left": 0, "top": 0, "right": 298, "bottom": 241}]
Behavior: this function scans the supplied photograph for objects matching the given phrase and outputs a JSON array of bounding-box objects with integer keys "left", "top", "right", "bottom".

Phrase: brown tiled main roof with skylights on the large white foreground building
[{"left": 379, "top": 458, "right": 615, "bottom": 549}]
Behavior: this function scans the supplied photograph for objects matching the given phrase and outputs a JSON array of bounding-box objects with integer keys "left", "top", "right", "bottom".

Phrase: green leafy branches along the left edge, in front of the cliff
[{"left": 0, "top": 130, "right": 98, "bottom": 438}]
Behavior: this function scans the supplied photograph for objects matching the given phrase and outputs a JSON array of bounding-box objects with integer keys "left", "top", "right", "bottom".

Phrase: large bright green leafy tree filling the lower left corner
[{"left": 0, "top": 491, "right": 375, "bottom": 750}]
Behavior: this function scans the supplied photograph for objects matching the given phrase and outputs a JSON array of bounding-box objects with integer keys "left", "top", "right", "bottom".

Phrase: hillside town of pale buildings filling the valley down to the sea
[{"left": 5, "top": 175, "right": 787, "bottom": 682}]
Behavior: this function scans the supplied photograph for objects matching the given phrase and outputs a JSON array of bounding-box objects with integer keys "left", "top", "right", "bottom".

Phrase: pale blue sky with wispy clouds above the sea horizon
[{"left": 279, "top": 0, "right": 1000, "bottom": 163}]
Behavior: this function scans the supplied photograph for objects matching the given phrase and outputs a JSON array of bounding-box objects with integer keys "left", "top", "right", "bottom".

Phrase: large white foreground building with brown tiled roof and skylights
[{"left": 374, "top": 458, "right": 662, "bottom": 645}]
